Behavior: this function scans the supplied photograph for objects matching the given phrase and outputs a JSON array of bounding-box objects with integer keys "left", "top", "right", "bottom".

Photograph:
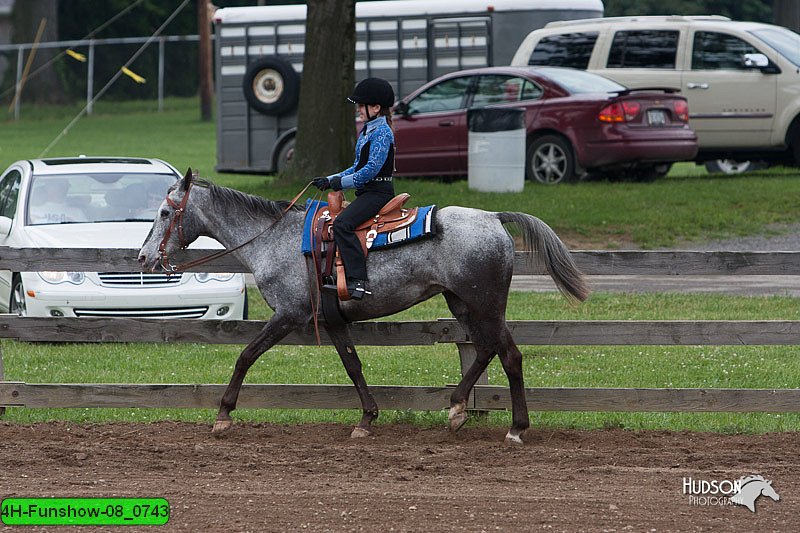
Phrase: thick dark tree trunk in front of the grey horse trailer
[{"left": 281, "top": 0, "right": 356, "bottom": 181}]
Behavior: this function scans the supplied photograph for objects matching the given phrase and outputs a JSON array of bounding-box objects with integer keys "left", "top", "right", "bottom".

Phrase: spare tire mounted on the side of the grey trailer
[{"left": 242, "top": 56, "right": 300, "bottom": 115}]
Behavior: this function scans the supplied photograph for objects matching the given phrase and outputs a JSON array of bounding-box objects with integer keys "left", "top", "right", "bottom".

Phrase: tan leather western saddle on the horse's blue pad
[{"left": 313, "top": 191, "right": 418, "bottom": 301}]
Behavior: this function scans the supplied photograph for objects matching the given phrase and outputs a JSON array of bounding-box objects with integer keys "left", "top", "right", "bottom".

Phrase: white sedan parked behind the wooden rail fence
[{"left": 0, "top": 156, "right": 247, "bottom": 319}]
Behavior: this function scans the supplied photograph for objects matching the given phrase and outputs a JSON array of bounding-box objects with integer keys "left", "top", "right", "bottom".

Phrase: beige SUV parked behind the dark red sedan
[{"left": 512, "top": 16, "right": 800, "bottom": 172}]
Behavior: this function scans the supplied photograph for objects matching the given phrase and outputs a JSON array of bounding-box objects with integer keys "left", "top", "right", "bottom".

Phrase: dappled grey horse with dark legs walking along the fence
[{"left": 138, "top": 171, "right": 590, "bottom": 444}]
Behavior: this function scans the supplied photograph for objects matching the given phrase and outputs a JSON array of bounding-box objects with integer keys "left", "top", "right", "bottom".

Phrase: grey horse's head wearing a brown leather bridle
[{"left": 139, "top": 168, "right": 200, "bottom": 272}]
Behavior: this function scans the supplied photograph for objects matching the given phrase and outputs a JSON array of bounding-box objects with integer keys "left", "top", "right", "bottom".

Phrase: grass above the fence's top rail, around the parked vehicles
[{"left": 0, "top": 95, "right": 800, "bottom": 248}]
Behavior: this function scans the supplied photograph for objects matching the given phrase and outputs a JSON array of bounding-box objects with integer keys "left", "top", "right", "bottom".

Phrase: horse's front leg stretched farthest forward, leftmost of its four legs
[{"left": 211, "top": 314, "right": 303, "bottom": 434}]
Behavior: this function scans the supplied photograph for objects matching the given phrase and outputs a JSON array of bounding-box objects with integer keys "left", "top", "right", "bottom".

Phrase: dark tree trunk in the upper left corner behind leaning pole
[{"left": 12, "top": 0, "right": 69, "bottom": 104}]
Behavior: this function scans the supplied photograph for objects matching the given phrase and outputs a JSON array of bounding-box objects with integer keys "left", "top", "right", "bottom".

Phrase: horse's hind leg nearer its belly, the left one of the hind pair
[{"left": 444, "top": 292, "right": 496, "bottom": 431}]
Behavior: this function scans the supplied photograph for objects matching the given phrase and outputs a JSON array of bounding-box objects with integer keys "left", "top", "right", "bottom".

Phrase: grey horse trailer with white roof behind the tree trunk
[{"left": 214, "top": 0, "right": 603, "bottom": 173}]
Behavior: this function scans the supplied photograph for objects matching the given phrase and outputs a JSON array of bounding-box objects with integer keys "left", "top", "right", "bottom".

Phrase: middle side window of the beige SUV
[{"left": 607, "top": 30, "right": 678, "bottom": 68}]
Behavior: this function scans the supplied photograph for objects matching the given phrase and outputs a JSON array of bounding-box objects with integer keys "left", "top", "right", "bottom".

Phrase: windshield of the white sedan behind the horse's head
[{"left": 27, "top": 173, "right": 176, "bottom": 226}]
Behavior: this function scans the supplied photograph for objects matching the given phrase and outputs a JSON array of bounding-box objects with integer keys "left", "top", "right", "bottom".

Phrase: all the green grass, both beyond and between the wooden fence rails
[{"left": 0, "top": 100, "right": 800, "bottom": 432}]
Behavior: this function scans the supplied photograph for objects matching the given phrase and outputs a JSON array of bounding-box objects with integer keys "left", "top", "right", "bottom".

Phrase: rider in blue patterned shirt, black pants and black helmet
[{"left": 313, "top": 78, "right": 394, "bottom": 300}]
